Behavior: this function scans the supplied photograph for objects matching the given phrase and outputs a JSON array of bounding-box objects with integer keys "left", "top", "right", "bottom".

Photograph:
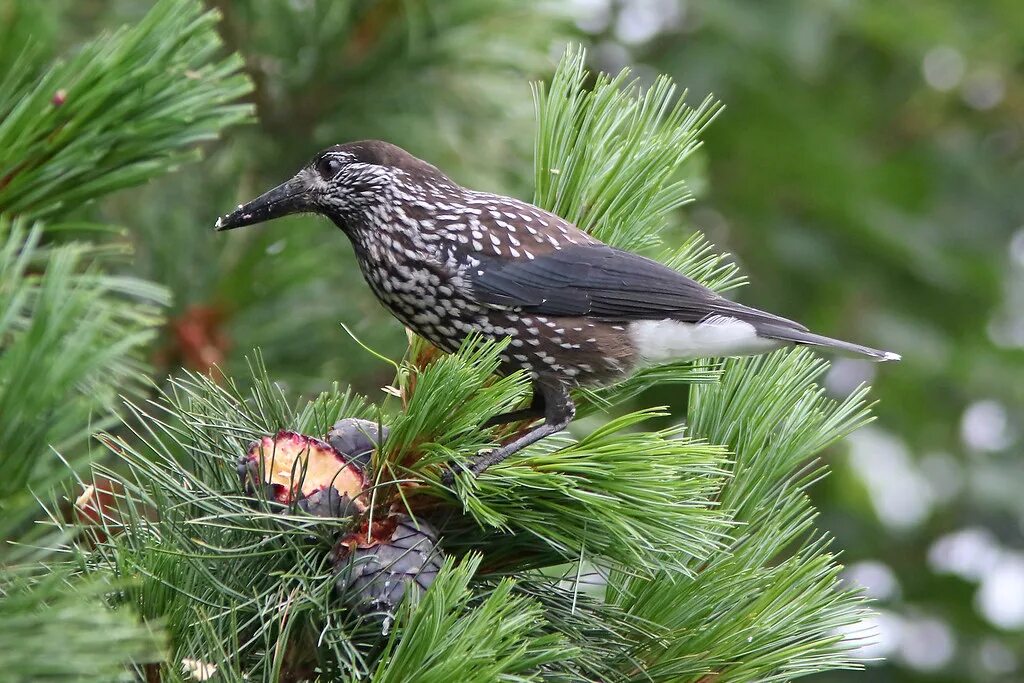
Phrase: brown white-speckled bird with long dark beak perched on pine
[{"left": 215, "top": 140, "right": 900, "bottom": 482}]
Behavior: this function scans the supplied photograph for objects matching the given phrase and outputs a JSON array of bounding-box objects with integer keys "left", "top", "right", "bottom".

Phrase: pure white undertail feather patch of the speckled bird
[{"left": 629, "top": 315, "right": 782, "bottom": 361}]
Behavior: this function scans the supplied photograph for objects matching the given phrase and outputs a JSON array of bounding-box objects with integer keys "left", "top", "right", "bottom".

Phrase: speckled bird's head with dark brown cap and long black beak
[{"left": 216, "top": 140, "right": 451, "bottom": 230}]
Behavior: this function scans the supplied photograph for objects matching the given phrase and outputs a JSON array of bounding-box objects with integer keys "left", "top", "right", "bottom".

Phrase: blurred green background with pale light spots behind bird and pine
[{"left": 12, "top": 0, "right": 1024, "bottom": 682}]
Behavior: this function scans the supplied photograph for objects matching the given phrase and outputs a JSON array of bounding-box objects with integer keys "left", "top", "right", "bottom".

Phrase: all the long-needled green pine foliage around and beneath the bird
[{"left": 0, "top": 0, "right": 869, "bottom": 683}]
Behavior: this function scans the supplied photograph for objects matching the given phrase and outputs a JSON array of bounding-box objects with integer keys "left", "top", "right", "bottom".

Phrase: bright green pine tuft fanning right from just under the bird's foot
[{"left": 444, "top": 411, "right": 727, "bottom": 572}]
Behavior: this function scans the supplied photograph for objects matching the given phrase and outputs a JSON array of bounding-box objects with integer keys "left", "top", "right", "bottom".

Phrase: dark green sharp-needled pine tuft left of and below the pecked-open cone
[{"left": 40, "top": 361, "right": 380, "bottom": 681}]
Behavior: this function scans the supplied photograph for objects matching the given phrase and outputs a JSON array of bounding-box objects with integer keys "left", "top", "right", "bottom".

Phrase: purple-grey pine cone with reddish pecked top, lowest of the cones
[{"left": 334, "top": 515, "right": 444, "bottom": 617}]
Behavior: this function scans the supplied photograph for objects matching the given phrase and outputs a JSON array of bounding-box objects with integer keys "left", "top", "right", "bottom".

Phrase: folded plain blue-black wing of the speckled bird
[{"left": 469, "top": 244, "right": 806, "bottom": 330}]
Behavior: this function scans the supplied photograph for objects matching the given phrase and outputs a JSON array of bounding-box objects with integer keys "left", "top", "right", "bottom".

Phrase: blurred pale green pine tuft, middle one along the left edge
[{"left": 0, "top": 219, "right": 166, "bottom": 538}]
